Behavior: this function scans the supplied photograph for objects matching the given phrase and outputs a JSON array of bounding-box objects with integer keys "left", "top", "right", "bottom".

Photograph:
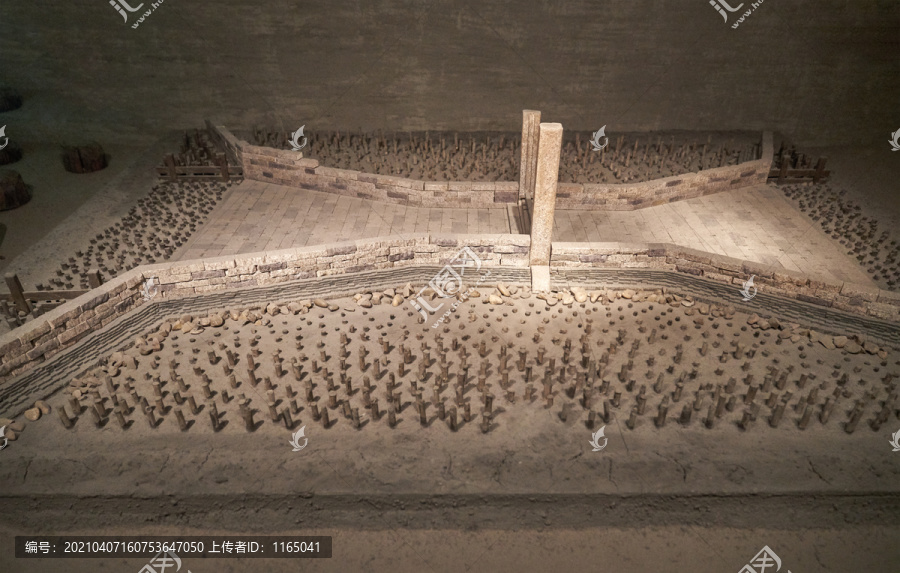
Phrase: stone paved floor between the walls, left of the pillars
[{"left": 175, "top": 181, "right": 514, "bottom": 260}]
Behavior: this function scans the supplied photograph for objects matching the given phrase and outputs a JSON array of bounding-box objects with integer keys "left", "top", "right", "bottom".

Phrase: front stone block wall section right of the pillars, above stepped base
[{"left": 550, "top": 243, "right": 900, "bottom": 322}]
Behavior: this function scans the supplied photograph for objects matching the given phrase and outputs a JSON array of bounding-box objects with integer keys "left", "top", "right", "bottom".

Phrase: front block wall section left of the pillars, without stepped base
[{"left": 0, "top": 234, "right": 530, "bottom": 381}]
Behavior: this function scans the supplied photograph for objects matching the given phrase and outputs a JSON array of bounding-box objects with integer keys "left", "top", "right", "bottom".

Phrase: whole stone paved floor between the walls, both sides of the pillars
[{"left": 175, "top": 181, "right": 873, "bottom": 285}]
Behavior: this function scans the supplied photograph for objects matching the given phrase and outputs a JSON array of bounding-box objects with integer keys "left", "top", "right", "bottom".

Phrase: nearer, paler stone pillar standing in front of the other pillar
[{"left": 529, "top": 123, "right": 562, "bottom": 292}]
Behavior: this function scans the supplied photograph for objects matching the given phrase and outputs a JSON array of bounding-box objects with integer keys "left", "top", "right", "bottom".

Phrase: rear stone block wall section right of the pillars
[{"left": 556, "top": 131, "right": 774, "bottom": 211}]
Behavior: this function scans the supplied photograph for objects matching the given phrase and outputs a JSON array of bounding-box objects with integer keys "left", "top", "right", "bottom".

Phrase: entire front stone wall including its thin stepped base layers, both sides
[{"left": 0, "top": 235, "right": 900, "bottom": 415}]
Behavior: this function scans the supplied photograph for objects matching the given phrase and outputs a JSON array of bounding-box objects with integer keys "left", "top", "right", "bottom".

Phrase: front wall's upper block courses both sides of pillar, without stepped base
[{"left": 0, "top": 234, "right": 900, "bottom": 388}]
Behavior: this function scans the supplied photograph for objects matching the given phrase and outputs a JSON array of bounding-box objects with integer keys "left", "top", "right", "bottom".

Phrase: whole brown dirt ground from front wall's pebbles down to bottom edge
[{"left": 0, "top": 289, "right": 900, "bottom": 571}]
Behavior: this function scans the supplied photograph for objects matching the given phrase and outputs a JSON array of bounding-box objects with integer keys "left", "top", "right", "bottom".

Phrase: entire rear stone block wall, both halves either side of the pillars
[{"left": 206, "top": 120, "right": 774, "bottom": 211}]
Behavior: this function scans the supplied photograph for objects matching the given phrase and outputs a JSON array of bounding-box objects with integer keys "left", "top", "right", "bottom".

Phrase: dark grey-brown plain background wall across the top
[{"left": 0, "top": 0, "right": 900, "bottom": 144}]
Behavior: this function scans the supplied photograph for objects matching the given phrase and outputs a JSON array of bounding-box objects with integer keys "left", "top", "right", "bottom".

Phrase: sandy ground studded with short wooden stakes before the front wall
[{"left": 29, "top": 287, "right": 900, "bottom": 440}]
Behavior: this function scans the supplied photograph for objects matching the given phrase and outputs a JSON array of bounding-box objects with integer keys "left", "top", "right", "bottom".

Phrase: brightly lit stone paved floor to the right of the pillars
[{"left": 553, "top": 185, "right": 874, "bottom": 285}]
